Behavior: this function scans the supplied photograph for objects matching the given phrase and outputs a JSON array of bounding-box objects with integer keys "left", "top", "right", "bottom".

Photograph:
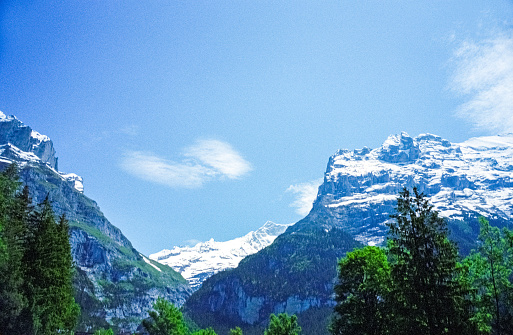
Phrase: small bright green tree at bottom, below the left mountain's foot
[{"left": 143, "top": 298, "right": 187, "bottom": 335}]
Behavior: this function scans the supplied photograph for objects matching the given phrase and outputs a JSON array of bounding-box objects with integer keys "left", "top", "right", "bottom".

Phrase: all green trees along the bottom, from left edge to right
[{"left": 0, "top": 164, "right": 513, "bottom": 335}]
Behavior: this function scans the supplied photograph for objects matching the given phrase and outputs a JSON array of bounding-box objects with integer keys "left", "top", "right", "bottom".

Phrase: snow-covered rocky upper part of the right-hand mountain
[{"left": 310, "top": 132, "right": 513, "bottom": 244}]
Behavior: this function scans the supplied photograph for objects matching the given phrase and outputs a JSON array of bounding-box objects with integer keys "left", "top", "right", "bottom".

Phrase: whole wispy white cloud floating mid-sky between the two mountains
[{"left": 121, "top": 140, "right": 251, "bottom": 188}]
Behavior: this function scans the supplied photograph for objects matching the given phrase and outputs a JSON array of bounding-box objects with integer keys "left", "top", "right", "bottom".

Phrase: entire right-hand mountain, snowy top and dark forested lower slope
[{"left": 185, "top": 133, "right": 513, "bottom": 334}]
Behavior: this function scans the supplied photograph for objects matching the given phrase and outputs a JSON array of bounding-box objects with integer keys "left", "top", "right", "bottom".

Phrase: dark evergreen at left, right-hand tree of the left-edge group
[{"left": 25, "top": 197, "right": 80, "bottom": 335}]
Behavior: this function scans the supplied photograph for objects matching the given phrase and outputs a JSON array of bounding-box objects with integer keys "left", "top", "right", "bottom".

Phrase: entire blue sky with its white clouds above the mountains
[{"left": 0, "top": 0, "right": 513, "bottom": 254}]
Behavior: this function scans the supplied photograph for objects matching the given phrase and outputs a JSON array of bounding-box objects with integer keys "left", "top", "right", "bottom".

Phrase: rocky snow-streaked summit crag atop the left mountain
[{"left": 0, "top": 112, "right": 84, "bottom": 192}]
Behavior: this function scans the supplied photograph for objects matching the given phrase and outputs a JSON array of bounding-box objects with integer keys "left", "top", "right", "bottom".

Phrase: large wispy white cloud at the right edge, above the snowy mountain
[{"left": 450, "top": 31, "right": 513, "bottom": 132}]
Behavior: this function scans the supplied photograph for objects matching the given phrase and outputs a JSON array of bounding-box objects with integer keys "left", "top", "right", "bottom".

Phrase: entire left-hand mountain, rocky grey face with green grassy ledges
[{"left": 0, "top": 114, "right": 192, "bottom": 331}]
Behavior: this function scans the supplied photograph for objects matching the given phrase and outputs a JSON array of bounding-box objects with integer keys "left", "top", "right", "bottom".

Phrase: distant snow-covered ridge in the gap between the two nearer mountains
[{"left": 149, "top": 221, "right": 289, "bottom": 290}]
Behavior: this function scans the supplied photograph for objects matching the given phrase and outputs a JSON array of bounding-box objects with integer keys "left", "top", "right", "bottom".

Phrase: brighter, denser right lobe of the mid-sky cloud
[{"left": 185, "top": 140, "right": 251, "bottom": 179}]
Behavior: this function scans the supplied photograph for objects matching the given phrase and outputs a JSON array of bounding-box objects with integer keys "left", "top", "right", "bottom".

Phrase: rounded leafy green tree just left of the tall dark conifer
[{"left": 331, "top": 246, "right": 393, "bottom": 335}]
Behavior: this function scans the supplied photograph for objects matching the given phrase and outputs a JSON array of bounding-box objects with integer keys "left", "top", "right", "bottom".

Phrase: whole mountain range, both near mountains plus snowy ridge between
[{"left": 0, "top": 112, "right": 513, "bottom": 335}]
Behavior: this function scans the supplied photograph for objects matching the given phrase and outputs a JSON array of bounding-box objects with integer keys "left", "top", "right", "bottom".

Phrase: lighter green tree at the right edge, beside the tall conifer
[{"left": 462, "top": 218, "right": 513, "bottom": 334}]
